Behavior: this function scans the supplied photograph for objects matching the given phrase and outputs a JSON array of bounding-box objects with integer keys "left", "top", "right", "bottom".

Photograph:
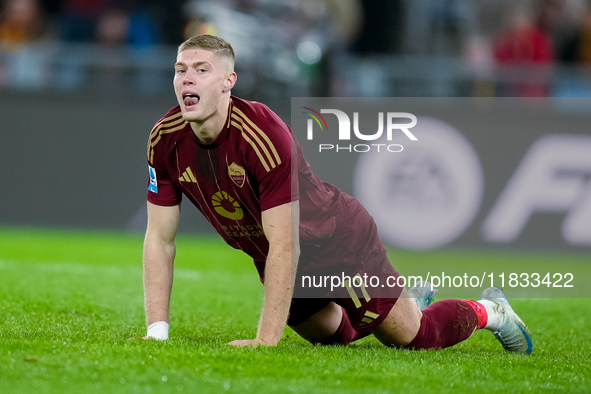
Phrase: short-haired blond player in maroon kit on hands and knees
[{"left": 144, "top": 35, "right": 532, "bottom": 353}]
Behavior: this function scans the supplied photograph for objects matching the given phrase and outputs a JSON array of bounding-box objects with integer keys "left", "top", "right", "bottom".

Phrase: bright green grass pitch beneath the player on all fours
[{"left": 0, "top": 227, "right": 591, "bottom": 394}]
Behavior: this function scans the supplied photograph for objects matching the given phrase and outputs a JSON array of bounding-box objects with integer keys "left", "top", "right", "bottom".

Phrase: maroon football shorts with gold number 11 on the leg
[{"left": 288, "top": 195, "right": 403, "bottom": 332}]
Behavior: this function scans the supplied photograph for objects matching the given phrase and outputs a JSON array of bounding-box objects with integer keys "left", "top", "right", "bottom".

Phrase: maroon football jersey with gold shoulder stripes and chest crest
[{"left": 148, "top": 96, "right": 341, "bottom": 271}]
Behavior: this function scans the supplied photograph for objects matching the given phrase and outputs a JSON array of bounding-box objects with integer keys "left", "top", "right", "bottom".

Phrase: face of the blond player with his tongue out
[{"left": 174, "top": 48, "right": 236, "bottom": 122}]
